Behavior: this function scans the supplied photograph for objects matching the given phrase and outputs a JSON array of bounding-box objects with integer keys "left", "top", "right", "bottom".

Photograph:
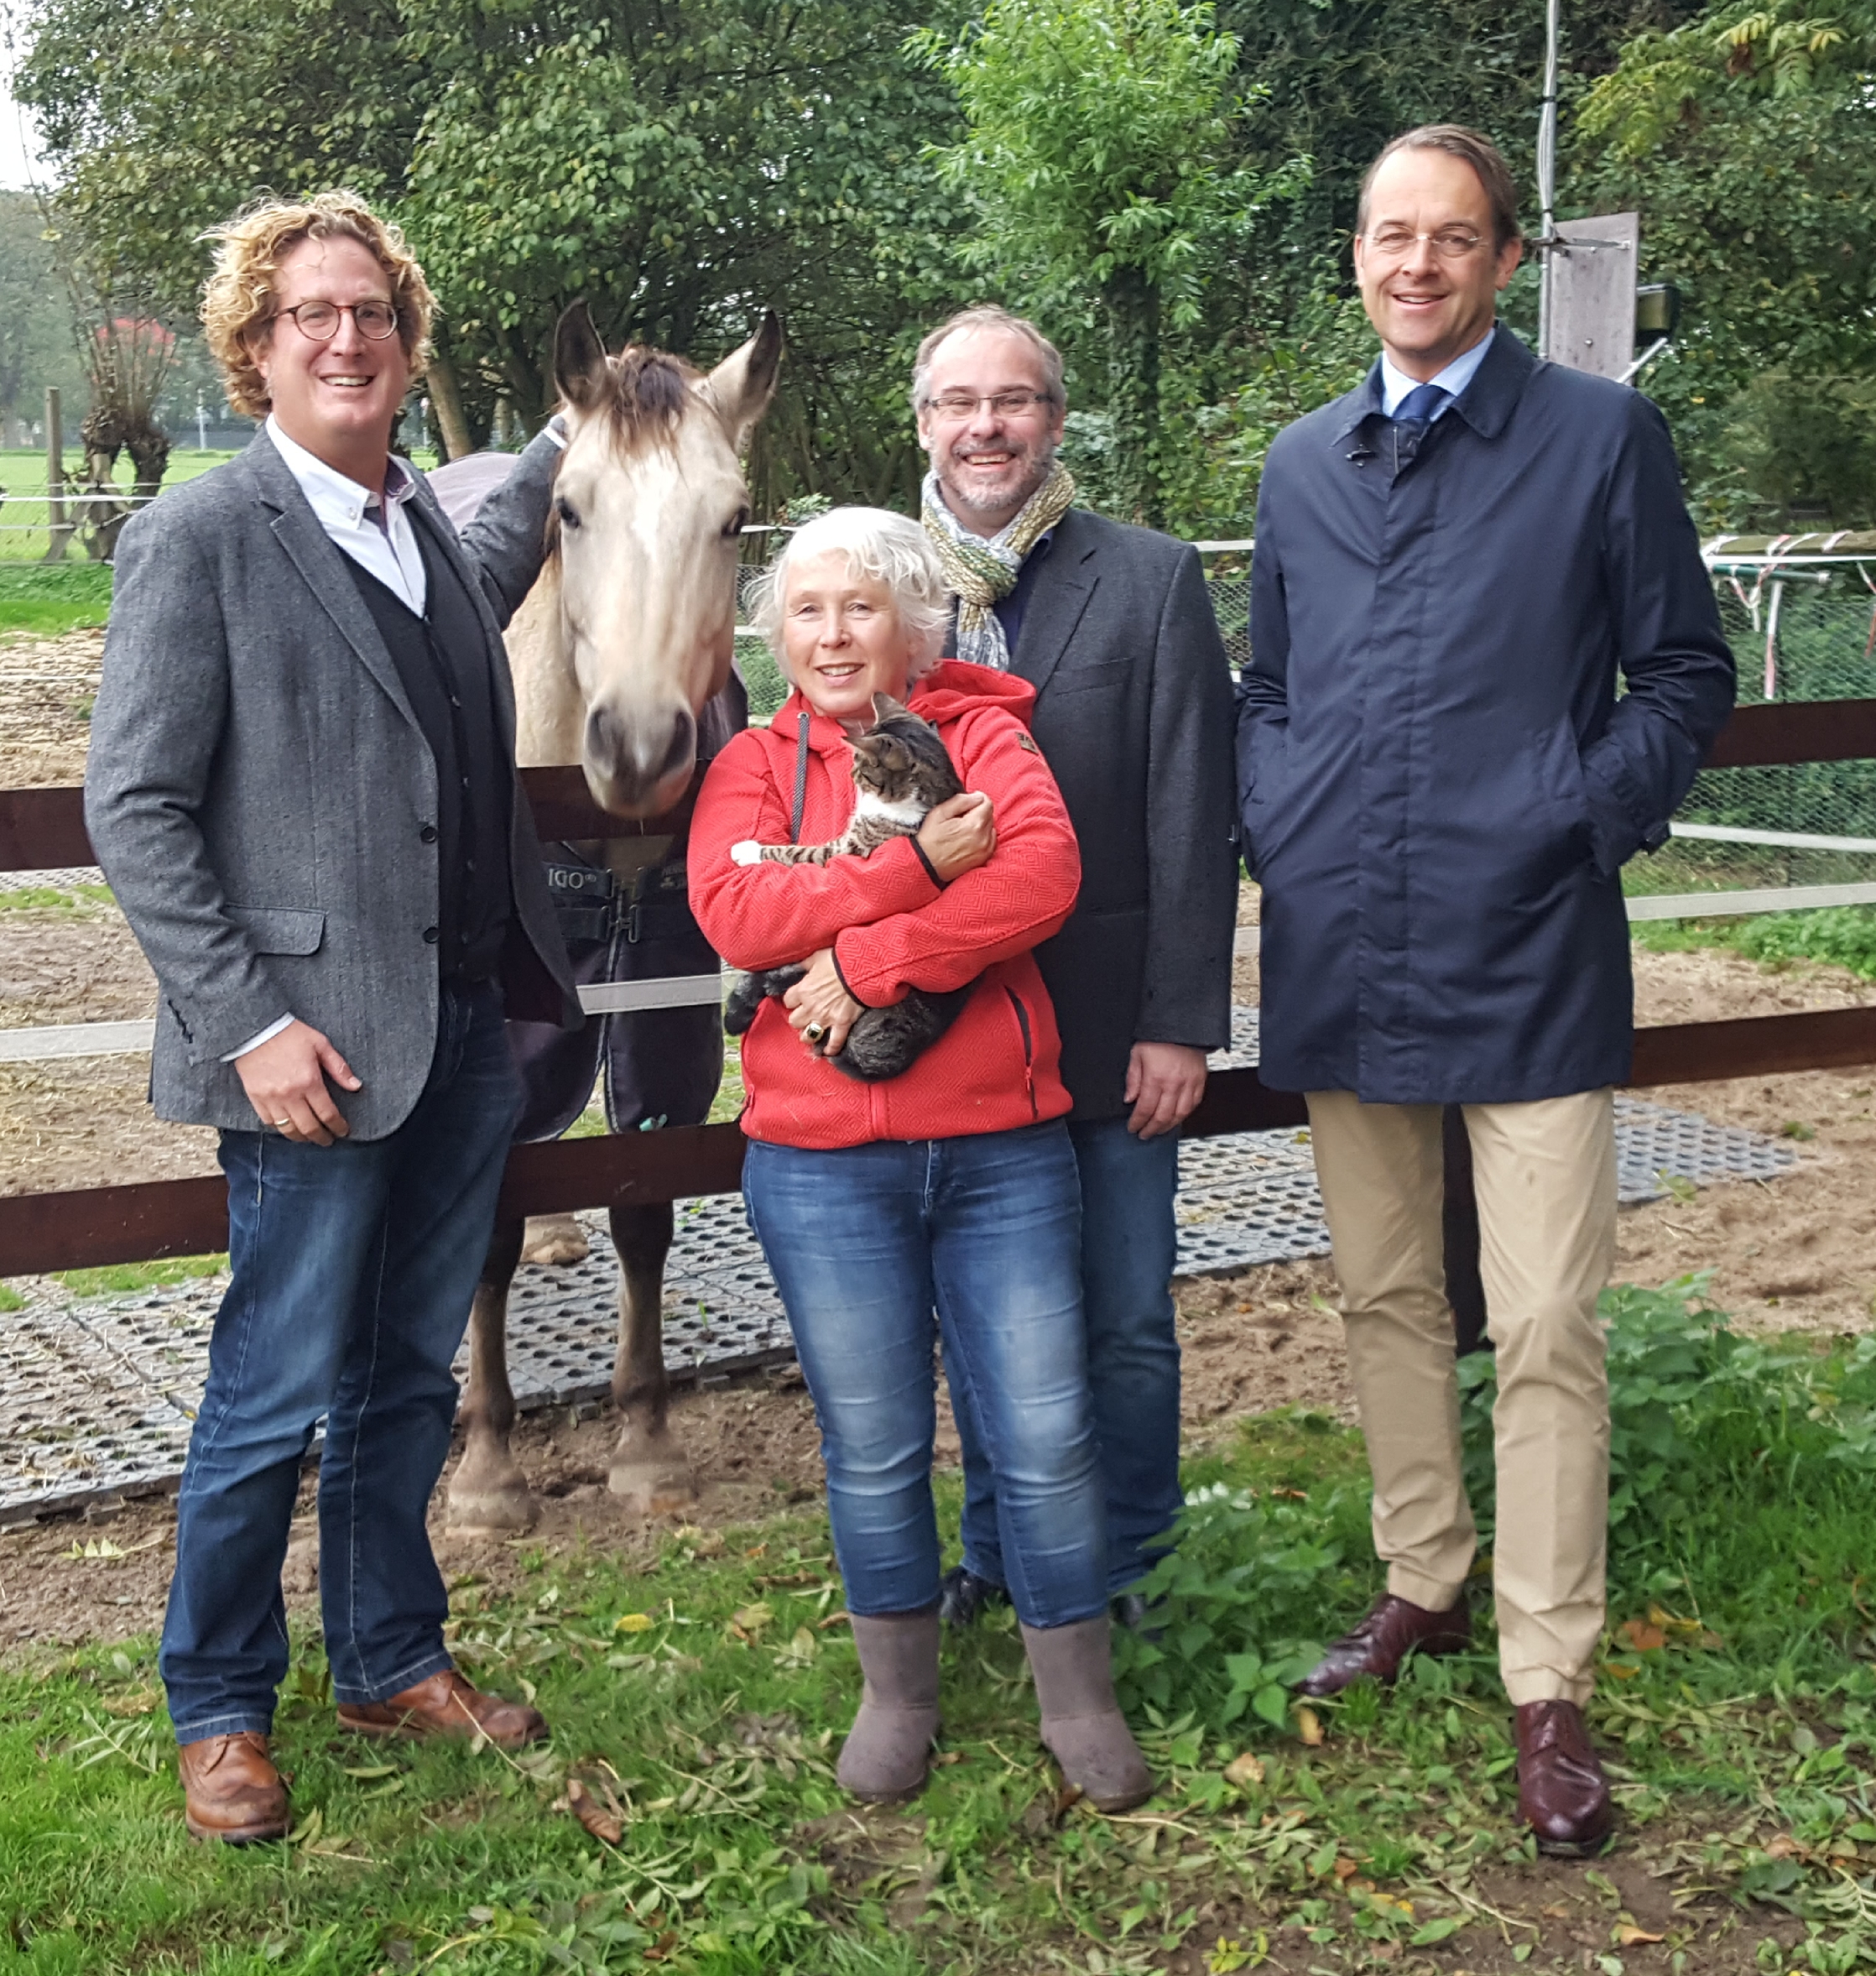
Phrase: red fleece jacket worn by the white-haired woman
[{"left": 686, "top": 660, "right": 1081, "bottom": 1150}]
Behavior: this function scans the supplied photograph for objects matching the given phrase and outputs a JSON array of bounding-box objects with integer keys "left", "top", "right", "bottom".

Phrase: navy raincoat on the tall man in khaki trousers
[{"left": 1238, "top": 326, "right": 1733, "bottom": 1104}]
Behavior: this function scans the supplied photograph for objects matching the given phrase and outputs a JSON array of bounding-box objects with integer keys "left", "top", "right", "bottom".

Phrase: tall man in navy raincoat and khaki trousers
[{"left": 1238, "top": 124, "right": 1733, "bottom": 1852}]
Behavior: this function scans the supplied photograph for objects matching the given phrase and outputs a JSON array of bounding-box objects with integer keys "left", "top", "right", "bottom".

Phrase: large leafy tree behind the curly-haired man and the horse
[{"left": 18, "top": 0, "right": 959, "bottom": 506}]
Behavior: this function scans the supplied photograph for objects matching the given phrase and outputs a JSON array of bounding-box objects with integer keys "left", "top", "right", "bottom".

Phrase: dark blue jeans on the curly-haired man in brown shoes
[{"left": 160, "top": 984, "right": 520, "bottom": 1743}]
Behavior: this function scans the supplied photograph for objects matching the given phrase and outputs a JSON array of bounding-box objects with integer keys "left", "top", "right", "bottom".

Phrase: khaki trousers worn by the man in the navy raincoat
[{"left": 1309, "top": 1091, "right": 1615, "bottom": 1705}]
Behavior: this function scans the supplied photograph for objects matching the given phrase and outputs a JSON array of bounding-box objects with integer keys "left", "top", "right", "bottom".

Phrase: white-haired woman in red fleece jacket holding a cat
[{"left": 688, "top": 508, "right": 1153, "bottom": 1810}]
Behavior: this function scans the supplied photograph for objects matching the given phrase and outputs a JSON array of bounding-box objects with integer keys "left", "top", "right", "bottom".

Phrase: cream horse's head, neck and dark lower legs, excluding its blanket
[{"left": 449, "top": 305, "right": 781, "bottom": 1531}]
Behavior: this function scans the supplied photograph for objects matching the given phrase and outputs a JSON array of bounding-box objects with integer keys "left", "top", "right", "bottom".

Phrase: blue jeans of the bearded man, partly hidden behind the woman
[{"left": 947, "top": 1114, "right": 1184, "bottom": 1593}]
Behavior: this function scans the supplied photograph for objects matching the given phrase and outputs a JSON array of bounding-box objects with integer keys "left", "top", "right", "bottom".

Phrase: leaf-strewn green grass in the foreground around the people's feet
[{"left": 11, "top": 1285, "right": 1876, "bottom": 1976}]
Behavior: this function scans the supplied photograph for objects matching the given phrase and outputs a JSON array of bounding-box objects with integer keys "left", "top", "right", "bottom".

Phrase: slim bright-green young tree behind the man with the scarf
[{"left": 914, "top": 0, "right": 1306, "bottom": 525}]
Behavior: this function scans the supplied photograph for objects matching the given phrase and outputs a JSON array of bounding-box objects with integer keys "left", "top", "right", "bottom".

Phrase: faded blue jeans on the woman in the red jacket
[{"left": 743, "top": 1123, "right": 1107, "bottom": 1626}]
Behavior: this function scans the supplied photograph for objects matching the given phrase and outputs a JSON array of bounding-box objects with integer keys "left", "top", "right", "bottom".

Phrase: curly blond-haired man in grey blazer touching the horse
[{"left": 85, "top": 191, "right": 579, "bottom": 1843}]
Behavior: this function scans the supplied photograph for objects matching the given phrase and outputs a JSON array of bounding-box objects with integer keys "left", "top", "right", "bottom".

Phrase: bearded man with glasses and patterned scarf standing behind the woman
[{"left": 911, "top": 308, "right": 1238, "bottom": 1666}]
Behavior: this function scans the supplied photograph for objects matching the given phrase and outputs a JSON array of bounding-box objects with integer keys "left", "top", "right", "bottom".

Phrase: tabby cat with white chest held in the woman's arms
[{"left": 723, "top": 694, "right": 975, "bottom": 1085}]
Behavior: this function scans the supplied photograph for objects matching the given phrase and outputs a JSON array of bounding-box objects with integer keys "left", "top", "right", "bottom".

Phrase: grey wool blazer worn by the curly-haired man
[{"left": 85, "top": 430, "right": 579, "bottom": 1140}]
